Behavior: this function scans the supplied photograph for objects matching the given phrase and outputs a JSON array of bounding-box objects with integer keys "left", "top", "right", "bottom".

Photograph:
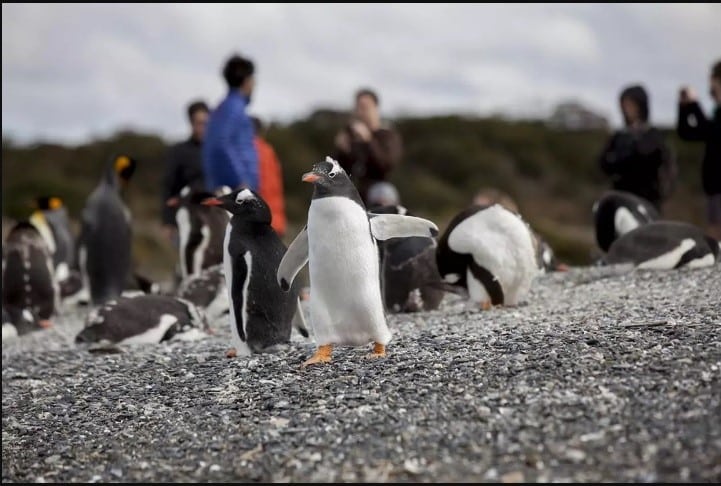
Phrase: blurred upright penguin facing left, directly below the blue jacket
[{"left": 166, "top": 186, "right": 229, "bottom": 278}]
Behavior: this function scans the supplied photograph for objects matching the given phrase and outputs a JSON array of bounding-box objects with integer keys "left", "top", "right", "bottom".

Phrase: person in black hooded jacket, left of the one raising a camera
[{"left": 600, "top": 85, "right": 676, "bottom": 210}]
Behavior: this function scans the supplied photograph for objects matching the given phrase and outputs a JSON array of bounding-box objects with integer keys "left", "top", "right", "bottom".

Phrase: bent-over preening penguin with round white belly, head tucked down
[{"left": 436, "top": 204, "right": 540, "bottom": 309}]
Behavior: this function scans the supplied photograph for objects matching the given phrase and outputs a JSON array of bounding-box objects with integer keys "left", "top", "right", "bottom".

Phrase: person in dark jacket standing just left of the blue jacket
[{"left": 161, "top": 100, "right": 209, "bottom": 241}]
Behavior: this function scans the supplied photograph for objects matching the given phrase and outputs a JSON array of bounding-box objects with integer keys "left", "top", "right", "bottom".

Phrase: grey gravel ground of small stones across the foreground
[{"left": 2, "top": 266, "right": 721, "bottom": 482}]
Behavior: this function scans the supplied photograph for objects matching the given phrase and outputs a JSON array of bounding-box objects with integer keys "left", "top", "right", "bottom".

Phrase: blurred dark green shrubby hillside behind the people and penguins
[{"left": 2, "top": 110, "right": 704, "bottom": 280}]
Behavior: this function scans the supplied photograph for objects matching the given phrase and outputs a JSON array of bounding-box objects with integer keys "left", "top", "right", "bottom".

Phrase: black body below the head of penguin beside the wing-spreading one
[{"left": 226, "top": 216, "right": 300, "bottom": 352}]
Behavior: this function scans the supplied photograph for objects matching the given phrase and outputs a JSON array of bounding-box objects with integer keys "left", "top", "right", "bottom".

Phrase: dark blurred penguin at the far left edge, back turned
[{"left": 2, "top": 221, "right": 59, "bottom": 334}]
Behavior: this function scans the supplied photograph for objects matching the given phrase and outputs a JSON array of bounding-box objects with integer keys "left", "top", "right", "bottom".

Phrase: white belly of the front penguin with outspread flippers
[{"left": 308, "top": 197, "right": 391, "bottom": 346}]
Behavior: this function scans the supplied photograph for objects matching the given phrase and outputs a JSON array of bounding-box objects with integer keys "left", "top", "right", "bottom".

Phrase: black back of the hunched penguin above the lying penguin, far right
[{"left": 593, "top": 191, "right": 660, "bottom": 251}]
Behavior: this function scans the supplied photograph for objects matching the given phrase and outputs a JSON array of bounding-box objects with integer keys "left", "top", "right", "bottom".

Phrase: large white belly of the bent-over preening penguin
[{"left": 448, "top": 205, "right": 540, "bottom": 305}]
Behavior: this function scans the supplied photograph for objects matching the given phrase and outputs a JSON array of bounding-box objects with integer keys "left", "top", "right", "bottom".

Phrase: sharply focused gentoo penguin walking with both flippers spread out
[{"left": 278, "top": 157, "right": 438, "bottom": 366}]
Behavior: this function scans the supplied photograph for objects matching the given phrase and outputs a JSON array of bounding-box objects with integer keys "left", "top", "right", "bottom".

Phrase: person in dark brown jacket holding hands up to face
[{"left": 335, "top": 88, "right": 402, "bottom": 203}]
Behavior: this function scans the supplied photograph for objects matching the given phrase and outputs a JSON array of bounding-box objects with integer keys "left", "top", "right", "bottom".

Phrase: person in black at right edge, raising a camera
[{"left": 676, "top": 60, "right": 721, "bottom": 241}]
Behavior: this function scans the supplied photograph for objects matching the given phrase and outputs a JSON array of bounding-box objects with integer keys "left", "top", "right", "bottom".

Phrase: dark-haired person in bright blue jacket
[{"left": 203, "top": 55, "right": 258, "bottom": 192}]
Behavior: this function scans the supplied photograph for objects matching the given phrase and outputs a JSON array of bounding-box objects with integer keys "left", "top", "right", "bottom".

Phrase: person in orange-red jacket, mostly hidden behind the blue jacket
[{"left": 251, "top": 116, "right": 287, "bottom": 237}]
